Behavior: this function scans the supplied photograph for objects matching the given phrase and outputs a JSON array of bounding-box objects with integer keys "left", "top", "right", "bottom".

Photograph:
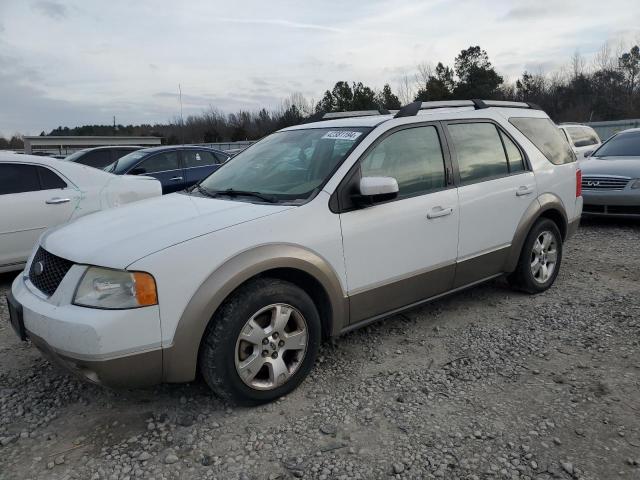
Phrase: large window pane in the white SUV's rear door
[{"left": 447, "top": 123, "right": 509, "bottom": 185}]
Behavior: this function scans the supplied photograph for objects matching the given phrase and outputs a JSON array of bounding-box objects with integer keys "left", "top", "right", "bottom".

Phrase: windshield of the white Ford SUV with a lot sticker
[{"left": 200, "top": 127, "right": 371, "bottom": 201}]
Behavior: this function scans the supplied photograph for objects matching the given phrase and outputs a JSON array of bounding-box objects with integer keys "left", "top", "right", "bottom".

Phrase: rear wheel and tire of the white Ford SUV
[{"left": 509, "top": 218, "right": 562, "bottom": 294}]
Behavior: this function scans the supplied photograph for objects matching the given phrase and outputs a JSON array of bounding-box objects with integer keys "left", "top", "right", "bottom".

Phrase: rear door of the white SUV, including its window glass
[{"left": 446, "top": 120, "right": 537, "bottom": 287}]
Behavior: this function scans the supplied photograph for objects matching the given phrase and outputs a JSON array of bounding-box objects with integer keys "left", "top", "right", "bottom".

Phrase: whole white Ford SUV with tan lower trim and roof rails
[{"left": 8, "top": 100, "right": 582, "bottom": 404}]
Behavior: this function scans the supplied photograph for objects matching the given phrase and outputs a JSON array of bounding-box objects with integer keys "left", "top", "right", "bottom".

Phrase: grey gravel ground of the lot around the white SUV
[{"left": 0, "top": 221, "right": 640, "bottom": 480}]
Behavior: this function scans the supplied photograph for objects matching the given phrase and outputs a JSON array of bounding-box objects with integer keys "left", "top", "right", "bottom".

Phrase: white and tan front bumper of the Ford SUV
[{"left": 10, "top": 272, "right": 162, "bottom": 387}]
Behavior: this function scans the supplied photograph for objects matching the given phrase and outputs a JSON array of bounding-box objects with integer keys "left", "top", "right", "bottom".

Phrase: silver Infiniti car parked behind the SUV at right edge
[{"left": 580, "top": 128, "right": 640, "bottom": 218}]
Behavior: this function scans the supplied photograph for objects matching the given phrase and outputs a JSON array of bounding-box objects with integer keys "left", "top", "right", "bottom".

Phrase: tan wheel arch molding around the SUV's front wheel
[{"left": 162, "top": 244, "right": 349, "bottom": 382}]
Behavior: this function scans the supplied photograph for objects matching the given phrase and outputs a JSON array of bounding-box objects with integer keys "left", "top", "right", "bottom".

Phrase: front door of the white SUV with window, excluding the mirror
[{"left": 339, "top": 123, "right": 458, "bottom": 323}]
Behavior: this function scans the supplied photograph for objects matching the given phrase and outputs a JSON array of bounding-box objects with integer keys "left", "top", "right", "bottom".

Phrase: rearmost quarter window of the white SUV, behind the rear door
[{"left": 509, "top": 117, "right": 576, "bottom": 165}]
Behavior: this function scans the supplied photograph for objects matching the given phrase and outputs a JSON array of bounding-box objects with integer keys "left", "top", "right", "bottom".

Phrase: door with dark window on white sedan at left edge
[{"left": 0, "top": 163, "right": 79, "bottom": 267}]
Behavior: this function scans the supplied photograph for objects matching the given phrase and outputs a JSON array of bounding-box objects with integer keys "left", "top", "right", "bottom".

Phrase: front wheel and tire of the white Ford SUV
[{"left": 198, "top": 278, "right": 321, "bottom": 405}]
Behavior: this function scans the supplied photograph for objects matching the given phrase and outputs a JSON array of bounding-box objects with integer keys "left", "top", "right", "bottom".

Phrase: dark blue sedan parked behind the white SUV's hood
[{"left": 104, "top": 145, "right": 230, "bottom": 193}]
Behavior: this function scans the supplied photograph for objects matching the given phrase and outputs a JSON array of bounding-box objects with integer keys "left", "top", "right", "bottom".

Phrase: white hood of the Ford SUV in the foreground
[{"left": 40, "top": 193, "right": 294, "bottom": 268}]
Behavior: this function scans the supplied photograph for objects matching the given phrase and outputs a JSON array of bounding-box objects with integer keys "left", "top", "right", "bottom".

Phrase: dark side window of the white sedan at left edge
[{"left": 0, "top": 163, "right": 67, "bottom": 195}]
